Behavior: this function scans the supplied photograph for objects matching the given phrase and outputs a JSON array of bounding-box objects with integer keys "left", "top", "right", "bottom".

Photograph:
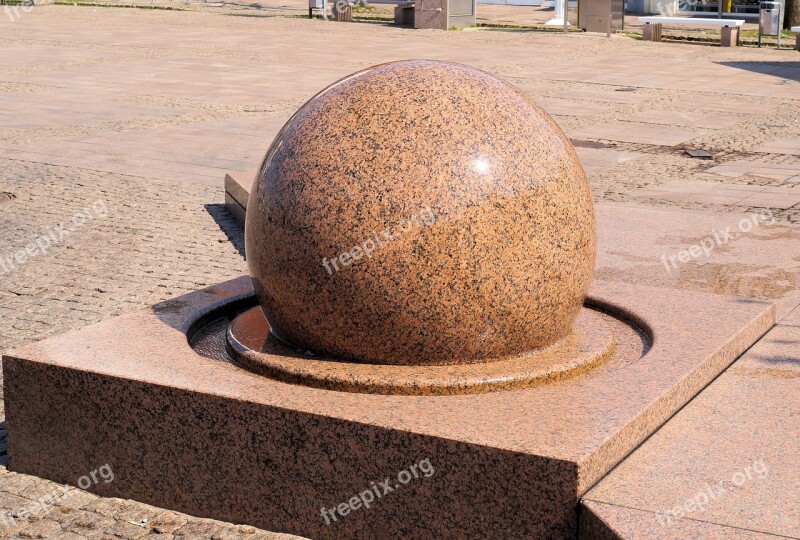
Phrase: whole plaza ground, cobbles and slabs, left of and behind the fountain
[{"left": 0, "top": 2, "right": 800, "bottom": 539}]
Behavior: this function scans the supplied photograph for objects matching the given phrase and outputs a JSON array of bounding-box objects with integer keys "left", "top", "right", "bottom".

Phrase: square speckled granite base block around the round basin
[{"left": 3, "top": 277, "right": 774, "bottom": 539}]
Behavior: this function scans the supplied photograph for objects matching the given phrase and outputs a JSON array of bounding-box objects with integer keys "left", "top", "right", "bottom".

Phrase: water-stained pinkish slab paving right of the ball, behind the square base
[{"left": 595, "top": 204, "right": 800, "bottom": 318}]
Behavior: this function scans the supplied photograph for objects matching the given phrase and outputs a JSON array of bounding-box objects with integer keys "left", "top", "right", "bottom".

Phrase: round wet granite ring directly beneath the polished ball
[{"left": 225, "top": 307, "right": 632, "bottom": 395}]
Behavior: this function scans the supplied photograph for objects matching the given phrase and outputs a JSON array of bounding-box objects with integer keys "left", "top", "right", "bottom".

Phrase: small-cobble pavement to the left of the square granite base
[{"left": 0, "top": 159, "right": 306, "bottom": 540}]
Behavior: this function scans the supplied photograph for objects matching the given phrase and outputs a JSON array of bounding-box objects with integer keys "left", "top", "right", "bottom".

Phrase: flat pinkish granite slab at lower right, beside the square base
[{"left": 584, "top": 323, "right": 800, "bottom": 540}]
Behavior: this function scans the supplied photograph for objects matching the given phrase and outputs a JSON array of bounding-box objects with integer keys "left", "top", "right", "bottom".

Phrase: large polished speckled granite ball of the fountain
[{"left": 245, "top": 60, "right": 595, "bottom": 365}]
